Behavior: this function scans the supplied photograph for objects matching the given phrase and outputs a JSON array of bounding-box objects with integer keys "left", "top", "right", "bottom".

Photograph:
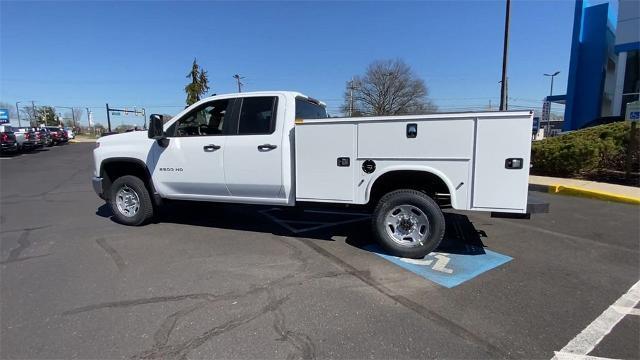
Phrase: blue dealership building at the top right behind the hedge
[{"left": 547, "top": 0, "right": 640, "bottom": 131}]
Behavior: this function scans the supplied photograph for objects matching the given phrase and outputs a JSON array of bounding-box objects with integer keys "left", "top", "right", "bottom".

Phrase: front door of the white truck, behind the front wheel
[{"left": 152, "top": 99, "right": 234, "bottom": 199}]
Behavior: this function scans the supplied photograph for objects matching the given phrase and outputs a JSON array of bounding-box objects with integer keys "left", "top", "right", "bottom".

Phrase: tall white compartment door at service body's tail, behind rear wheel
[{"left": 472, "top": 116, "right": 532, "bottom": 213}]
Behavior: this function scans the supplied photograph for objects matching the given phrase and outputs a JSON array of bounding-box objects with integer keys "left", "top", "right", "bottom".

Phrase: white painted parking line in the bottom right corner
[{"left": 552, "top": 281, "right": 640, "bottom": 360}]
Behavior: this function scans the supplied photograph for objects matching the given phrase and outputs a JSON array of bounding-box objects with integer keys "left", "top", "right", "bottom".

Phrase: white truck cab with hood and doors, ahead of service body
[{"left": 94, "top": 92, "right": 316, "bottom": 205}]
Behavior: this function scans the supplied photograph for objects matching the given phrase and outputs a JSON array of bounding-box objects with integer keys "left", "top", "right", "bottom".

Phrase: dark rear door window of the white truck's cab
[{"left": 238, "top": 96, "right": 278, "bottom": 135}]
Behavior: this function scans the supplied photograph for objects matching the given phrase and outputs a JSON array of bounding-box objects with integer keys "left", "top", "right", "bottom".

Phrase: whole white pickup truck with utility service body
[{"left": 93, "top": 91, "right": 544, "bottom": 258}]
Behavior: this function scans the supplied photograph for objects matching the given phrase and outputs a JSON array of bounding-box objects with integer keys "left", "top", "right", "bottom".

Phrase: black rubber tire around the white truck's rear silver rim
[{"left": 372, "top": 189, "right": 445, "bottom": 259}]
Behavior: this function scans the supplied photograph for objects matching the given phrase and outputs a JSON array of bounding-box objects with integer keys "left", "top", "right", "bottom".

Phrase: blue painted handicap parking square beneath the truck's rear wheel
[{"left": 365, "top": 244, "right": 513, "bottom": 288}]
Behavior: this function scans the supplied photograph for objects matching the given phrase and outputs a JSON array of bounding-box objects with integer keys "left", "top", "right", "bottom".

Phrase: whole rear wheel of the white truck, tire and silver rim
[{"left": 372, "top": 189, "right": 445, "bottom": 258}]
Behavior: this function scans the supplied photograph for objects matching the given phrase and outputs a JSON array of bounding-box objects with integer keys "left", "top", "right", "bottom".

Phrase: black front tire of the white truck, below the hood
[{"left": 109, "top": 175, "right": 153, "bottom": 226}]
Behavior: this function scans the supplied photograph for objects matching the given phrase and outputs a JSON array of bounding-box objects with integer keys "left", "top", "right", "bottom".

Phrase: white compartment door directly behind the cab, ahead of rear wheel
[{"left": 295, "top": 123, "right": 357, "bottom": 203}]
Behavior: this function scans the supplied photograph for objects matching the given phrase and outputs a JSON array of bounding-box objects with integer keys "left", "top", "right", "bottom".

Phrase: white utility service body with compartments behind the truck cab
[{"left": 295, "top": 111, "right": 533, "bottom": 213}]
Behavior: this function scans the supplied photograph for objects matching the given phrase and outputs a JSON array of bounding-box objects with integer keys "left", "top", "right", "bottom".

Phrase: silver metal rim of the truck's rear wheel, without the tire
[{"left": 384, "top": 205, "right": 429, "bottom": 247}]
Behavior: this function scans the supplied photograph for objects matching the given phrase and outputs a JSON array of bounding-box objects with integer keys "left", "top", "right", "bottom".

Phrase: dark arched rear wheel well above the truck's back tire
[{"left": 369, "top": 170, "right": 451, "bottom": 205}]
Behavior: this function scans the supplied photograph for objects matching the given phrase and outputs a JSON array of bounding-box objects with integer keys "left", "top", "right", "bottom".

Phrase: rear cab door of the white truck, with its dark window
[{"left": 224, "top": 96, "right": 285, "bottom": 203}]
